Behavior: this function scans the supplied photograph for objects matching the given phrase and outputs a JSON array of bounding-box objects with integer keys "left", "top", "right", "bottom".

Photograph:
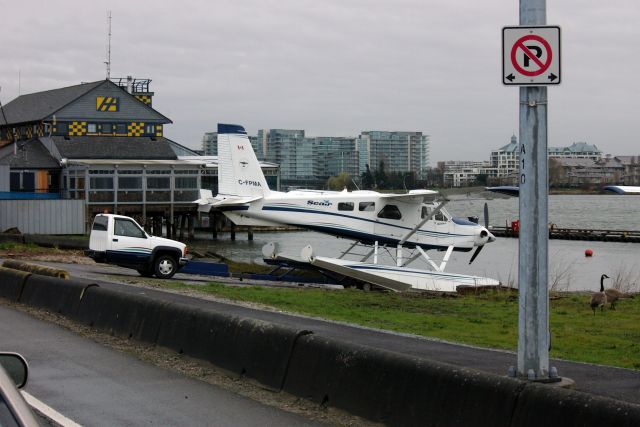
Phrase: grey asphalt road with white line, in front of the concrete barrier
[{"left": 0, "top": 305, "right": 320, "bottom": 427}]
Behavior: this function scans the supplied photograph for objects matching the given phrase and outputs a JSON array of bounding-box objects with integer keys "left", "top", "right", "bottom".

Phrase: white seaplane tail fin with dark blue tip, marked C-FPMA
[{"left": 218, "top": 123, "right": 270, "bottom": 198}]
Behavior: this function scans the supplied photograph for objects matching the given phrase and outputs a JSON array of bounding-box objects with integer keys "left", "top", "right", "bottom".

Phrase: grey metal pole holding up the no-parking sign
[{"left": 517, "top": 0, "right": 549, "bottom": 380}]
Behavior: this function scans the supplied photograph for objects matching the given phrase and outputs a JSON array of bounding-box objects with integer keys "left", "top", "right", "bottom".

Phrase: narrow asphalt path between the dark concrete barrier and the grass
[{"left": 51, "top": 263, "right": 640, "bottom": 404}]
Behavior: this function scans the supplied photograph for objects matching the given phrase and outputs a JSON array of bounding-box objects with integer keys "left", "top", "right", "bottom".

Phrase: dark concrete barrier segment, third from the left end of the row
[{"left": 74, "top": 287, "right": 168, "bottom": 343}]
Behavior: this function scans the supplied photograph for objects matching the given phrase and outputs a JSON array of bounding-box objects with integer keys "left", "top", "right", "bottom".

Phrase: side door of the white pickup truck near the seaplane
[{"left": 107, "top": 217, "right": 151, "bottom": 267}]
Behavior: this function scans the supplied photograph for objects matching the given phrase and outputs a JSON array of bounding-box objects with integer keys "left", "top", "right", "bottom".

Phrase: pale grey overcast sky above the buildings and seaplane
[{"left": 0, "top": 0, "right": 640, "bottom": 164}]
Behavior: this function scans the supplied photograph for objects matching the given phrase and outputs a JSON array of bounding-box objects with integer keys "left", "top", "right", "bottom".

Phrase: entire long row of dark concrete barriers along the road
[{"left": 0, "top": 268, "right": 640, "bottom": 427}]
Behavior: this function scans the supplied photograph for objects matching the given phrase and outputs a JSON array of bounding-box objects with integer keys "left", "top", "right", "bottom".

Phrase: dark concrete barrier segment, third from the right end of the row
[{"left": 157, "top": 304, "right": 309, "bottom": 390}]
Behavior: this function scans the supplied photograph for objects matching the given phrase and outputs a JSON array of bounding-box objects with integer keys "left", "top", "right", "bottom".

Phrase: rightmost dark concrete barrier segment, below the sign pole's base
[{"left": 511, "top": 384, "right": 640, "bottom": 427}]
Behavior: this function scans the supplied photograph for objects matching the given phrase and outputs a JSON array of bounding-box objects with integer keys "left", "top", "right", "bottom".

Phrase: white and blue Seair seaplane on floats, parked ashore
[{"left": 195, "top": 124, "right": 500, "bottom": 292}]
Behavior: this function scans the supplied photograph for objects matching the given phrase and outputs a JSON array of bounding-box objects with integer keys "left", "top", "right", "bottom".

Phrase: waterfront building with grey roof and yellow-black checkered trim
[{"left": 0, "top": 78, "right": 278, "bottom": 231}]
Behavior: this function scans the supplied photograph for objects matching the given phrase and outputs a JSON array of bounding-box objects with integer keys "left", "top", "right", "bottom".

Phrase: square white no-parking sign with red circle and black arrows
[{"left": 502, "top": 26, "right": 561, "bottom": 86}]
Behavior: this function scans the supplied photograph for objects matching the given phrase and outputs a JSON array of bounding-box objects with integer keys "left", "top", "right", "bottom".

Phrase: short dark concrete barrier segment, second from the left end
[{"left": 19, "top": 274, "right": 98, "bottom": 317}]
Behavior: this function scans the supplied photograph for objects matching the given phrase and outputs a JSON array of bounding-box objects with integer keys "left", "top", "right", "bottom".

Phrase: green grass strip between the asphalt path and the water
[{"left": 156, "top": 282, "right": 640, "bottom": 369}]
